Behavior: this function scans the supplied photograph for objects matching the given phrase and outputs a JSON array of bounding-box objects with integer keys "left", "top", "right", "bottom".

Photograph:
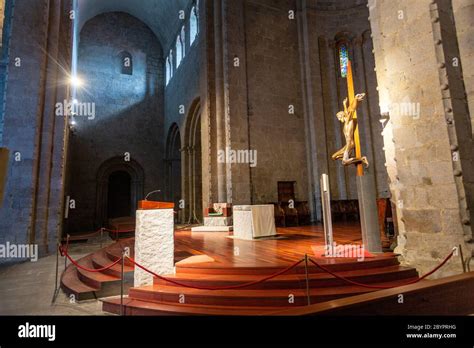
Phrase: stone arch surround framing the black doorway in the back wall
[{"left": 95, "top": 157, "right": 145, "bottom": 228}]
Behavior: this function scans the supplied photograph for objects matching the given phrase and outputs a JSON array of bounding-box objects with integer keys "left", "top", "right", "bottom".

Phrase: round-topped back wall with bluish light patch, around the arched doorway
[{"left": 68, "top": 12, "right": 165, "bottom": 232}]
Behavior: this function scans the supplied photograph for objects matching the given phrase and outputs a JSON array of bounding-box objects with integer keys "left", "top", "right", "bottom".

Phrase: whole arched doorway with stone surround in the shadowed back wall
[{"left": 95, "top": 157, "right": 145, "bottom": 228}]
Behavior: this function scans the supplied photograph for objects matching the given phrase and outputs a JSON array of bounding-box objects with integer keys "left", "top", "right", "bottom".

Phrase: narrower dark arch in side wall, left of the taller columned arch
[{"left": 165, "top": 123, "right": 184, "bottom": 222}]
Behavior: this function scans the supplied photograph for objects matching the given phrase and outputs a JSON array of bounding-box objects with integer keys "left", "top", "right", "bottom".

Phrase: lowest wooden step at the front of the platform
[{"left": 101, "top": 297, "right": 281, "bottom": 316}]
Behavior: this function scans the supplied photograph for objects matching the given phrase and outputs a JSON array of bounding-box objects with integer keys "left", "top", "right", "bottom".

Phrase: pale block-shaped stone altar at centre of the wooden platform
[{"left": 233, "top": 204, "right": 276, "bottom": 240}]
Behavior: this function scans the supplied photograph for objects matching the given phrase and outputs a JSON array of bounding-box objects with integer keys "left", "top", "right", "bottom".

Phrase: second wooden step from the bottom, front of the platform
[{"left": 129, "top": 277, "right": 417, "bottom": 307}]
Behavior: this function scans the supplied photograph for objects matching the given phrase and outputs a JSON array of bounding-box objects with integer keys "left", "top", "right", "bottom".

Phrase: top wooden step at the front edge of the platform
[{"left": 154, "top": 266, "right": 418, "bottom": 290}]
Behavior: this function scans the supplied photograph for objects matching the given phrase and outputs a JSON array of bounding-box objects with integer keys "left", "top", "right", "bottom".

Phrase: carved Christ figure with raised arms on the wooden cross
[{"left": 332, "top": 93, "right": 369, "bottom": 167}]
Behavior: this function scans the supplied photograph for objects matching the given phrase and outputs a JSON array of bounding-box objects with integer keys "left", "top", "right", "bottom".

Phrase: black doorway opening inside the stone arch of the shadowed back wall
[{"left": 107, "top": 171, "right": 132, "bottom": 219}]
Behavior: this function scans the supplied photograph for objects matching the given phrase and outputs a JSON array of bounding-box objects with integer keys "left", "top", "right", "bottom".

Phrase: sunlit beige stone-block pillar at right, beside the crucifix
[{"left": 368, "top": 0, "right": 472, "bottom": 277}]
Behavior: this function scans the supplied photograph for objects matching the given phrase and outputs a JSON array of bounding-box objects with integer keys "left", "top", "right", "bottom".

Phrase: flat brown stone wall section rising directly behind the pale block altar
[{"left": 245, "top": 0, "right": 308, "bottom": 204}]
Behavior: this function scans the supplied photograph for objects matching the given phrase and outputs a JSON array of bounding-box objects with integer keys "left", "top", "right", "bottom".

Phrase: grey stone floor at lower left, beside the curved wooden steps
[{"left": 0, "top": 240, "right": 111, "bottom": 315}]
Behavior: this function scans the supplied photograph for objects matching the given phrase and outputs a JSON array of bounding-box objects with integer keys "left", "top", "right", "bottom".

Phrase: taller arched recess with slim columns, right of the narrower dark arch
[{"left": 182, "top": 100, "right": 203, "bottom": 223}]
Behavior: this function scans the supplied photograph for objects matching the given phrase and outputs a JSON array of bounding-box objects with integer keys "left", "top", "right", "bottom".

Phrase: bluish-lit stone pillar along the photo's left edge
[{"left": 0, "top": 0, "right": 70, "bottom": 262}]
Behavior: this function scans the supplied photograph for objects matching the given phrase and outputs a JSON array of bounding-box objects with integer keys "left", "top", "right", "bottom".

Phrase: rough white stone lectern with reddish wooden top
[{"left": 134, "top": 201, "right": 175, "bottom": 287}]
